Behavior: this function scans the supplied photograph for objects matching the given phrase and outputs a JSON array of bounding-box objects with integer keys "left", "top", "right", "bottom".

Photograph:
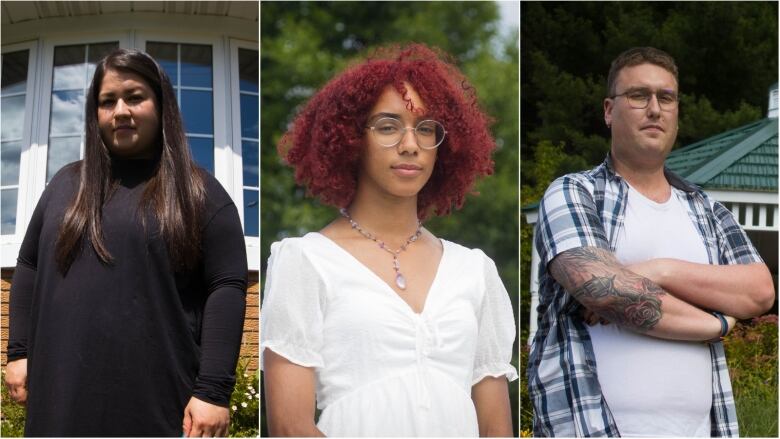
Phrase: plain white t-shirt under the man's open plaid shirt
[{"left": 588, "top": 187, "right": 712, "bottom": 437}]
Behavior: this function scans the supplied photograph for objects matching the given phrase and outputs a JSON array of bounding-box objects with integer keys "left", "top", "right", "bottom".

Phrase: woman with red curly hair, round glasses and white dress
[{"left": 260, "top": 44, "right": 517, "bottom": 436}]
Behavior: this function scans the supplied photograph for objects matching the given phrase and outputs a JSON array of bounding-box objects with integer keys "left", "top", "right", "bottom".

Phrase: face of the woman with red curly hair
[{"left": 358, "top": 83, "right": 436, "bottom": 202}]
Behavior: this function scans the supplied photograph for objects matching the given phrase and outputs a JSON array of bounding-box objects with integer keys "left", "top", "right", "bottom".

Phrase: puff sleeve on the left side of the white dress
[{"left": 260, "top": 238, "right": 325, "bottom": 368}]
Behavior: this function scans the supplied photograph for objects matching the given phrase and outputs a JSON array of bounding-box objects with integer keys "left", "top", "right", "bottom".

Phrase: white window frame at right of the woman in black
[{"left": 223, "top": 38, "right": 260, "bottom": 271}]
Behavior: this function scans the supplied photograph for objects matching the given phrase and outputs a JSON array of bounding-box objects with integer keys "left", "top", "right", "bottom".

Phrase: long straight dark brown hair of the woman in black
[{"left": 56, "top": 49, "right": 205, "bottom": 274}]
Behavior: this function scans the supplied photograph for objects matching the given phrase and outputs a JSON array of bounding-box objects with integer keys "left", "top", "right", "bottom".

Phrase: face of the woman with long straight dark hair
[{"left": 97, "top": 70, "right": 160, "bottom": 158}]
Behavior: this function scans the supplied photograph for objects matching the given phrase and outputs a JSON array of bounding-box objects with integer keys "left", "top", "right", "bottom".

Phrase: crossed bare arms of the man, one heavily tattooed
[{"left": 548, "top": 247, "right": 774, "bottom": 340}]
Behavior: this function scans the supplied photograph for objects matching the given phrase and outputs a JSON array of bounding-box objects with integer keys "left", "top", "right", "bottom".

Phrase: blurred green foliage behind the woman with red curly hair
[{"left": 260, "top": 2, "right": 519, "bottom": 436}]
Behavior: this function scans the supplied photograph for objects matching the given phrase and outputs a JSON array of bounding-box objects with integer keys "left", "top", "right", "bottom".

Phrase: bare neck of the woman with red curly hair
[{"left": 347, "top": 191, "right": 417, "bottom": 245}]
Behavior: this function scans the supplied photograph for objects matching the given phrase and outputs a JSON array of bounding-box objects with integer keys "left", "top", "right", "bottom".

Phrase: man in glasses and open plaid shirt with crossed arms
[{"left": 528, "top": 47, "right": 774, "bottom": 437}]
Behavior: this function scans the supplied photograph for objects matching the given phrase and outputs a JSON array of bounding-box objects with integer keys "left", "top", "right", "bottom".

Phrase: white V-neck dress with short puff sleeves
[{"left": 260, "top": 233, "right": 517, "bottom": 436}]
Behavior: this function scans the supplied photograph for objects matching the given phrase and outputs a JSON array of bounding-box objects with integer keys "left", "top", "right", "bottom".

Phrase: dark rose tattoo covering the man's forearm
[{"left": 550, "top": 247, "right": 666, "bottom": 332}]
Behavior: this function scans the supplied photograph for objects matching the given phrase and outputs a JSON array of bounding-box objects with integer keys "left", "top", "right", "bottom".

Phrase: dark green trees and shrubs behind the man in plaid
[{"left": 520, "top": 2, "right": 778, "bottom": 437}]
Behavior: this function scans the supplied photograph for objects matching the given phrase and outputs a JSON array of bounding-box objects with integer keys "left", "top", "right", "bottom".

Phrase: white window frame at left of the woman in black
[{"left": 0, "top": 40, "right": 40, "bottom": 267}]
